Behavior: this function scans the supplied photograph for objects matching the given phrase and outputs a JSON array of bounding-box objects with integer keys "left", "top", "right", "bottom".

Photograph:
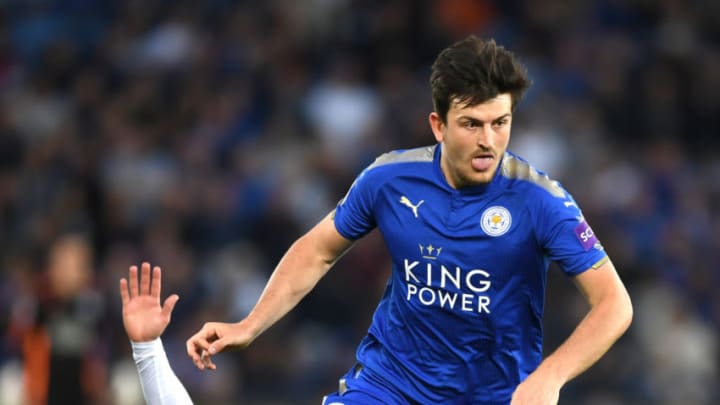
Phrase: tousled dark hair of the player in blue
[{"left": 430, "top": 35, "right": 530, "bottom": 123}]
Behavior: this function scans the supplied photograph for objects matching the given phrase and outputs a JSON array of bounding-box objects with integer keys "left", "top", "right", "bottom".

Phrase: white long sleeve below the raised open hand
[{"left": 130, "top": 338, "right": 192, "bottom": 405}]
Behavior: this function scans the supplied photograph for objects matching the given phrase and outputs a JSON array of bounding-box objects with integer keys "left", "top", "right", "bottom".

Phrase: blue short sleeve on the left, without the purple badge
[{"left": 334, "top": 169, "right": 376, "bottom": 240}]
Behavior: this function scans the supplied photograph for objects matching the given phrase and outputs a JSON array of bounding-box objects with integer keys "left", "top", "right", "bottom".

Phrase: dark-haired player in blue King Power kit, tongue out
[{"left": 187, "top": 36, "right": 632, "bottom": 405}]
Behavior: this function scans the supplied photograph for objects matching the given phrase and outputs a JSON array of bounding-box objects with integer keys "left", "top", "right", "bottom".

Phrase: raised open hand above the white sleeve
[{"left": 120, "top": 263, "right": 180, "bottom": 342}]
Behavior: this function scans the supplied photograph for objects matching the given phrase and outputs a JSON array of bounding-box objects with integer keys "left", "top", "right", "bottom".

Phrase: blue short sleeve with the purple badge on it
[{"left": 537, "top": 192, "right": 607, "bottom": 276}]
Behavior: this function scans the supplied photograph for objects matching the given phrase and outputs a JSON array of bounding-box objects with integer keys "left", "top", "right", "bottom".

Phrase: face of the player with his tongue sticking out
[{"left": 429, "top": 94, "right": 512, "bottom": 188}]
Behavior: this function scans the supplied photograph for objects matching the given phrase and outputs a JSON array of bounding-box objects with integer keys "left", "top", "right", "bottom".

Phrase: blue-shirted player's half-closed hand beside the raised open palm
[{"left": 185, "top": 322, "right": 254, "bottom": 370}]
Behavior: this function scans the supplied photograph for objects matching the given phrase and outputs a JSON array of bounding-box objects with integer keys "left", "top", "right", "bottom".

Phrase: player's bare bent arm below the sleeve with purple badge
[{"left": 512, "top": 260, "right": 633, "bottom": 405}]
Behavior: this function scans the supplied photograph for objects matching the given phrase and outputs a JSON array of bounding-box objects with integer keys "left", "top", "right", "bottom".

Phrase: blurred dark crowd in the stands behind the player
[{"left": 0, "top": 0, "right": 720, "bottom": 405}]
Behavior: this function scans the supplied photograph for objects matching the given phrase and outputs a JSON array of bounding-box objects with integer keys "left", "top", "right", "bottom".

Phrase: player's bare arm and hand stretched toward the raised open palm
[{"left": 186, "top": 212, "right": 352, "bottom": 370}]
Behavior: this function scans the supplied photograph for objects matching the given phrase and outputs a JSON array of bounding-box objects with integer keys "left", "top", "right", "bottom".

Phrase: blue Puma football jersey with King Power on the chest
[{"left": 334, "top": 145, "right": 607, "bottom": 404}]
